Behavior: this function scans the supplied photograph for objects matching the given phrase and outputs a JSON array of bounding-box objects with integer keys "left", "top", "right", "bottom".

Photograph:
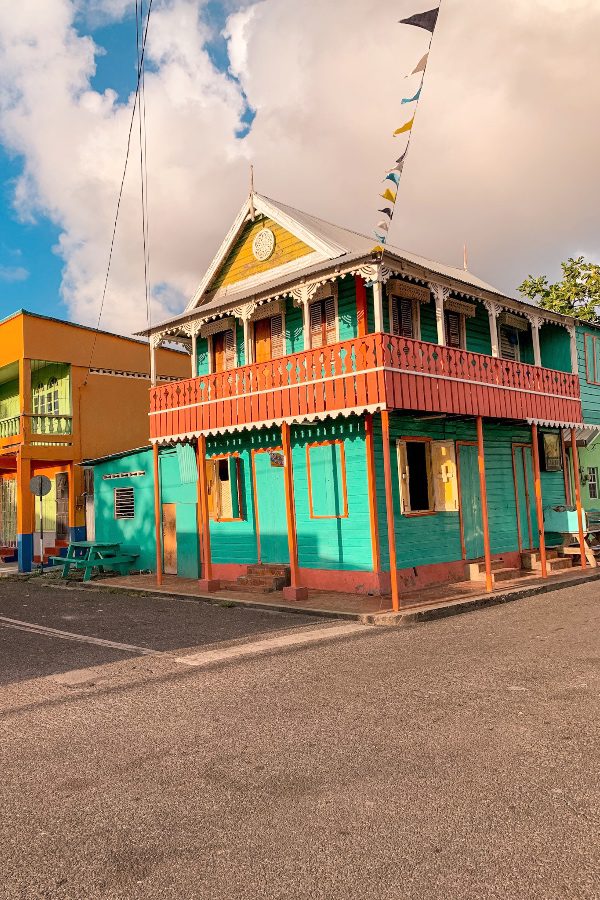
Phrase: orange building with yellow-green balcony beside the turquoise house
[{"left": 0, "top": 310, "right": 190, "bottom": 572}]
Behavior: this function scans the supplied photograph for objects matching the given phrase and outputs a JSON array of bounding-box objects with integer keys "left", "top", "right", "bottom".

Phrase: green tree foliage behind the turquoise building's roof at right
[{"left": 519, "top": 256, "right": 600, "bottom": 324}]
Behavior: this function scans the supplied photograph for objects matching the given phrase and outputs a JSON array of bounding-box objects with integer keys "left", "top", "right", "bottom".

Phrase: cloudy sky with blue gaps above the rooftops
[{"left": 0, "top": 0, "right": 600, "bottom": 333}]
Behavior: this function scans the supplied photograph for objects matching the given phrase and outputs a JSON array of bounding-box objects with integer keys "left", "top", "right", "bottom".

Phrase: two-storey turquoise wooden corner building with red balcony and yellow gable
[{"left": 94, "top": 194, "right": 600, "bottom": 607}]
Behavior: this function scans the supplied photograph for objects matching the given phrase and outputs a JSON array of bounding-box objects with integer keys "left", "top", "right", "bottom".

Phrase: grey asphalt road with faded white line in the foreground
[{"left": 0, "top": 581, "right": 600, "bottom": 900}]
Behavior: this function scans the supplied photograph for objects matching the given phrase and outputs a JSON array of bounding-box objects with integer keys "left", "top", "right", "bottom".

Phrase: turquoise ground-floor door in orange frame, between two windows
[{"left": 254, "top": 450, "right": 290, "bottom": 563}]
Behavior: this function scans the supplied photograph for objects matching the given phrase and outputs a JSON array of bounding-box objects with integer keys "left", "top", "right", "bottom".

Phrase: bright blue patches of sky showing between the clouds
[{"left": 0, "top": 0, "right": 254, "bottom": 318}]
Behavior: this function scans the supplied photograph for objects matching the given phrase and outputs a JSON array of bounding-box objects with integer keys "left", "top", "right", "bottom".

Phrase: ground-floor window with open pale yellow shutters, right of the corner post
[{"left": 397, "top": 438, "right": 458, "bottom": 515}]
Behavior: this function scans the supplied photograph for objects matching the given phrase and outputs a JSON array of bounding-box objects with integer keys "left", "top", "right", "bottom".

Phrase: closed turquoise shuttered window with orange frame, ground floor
[{"left": 306, "top": 441, "right": 348, "bottom": 519}]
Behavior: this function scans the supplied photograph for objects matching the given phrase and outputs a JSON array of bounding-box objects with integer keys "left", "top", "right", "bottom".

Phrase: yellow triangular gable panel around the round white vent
[{"left": 209, "top": 216, "right": 314, "bottom": 291}]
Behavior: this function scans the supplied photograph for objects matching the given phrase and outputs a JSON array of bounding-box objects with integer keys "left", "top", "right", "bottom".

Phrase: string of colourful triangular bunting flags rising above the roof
[{"left": 373, "top": 0, "right": 441, "bottom": 252}]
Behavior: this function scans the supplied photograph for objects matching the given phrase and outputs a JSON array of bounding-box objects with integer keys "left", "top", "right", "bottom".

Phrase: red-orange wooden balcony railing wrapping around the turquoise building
[{"left": 150, "top": 333, "right": 582, "bottom": 439}]
